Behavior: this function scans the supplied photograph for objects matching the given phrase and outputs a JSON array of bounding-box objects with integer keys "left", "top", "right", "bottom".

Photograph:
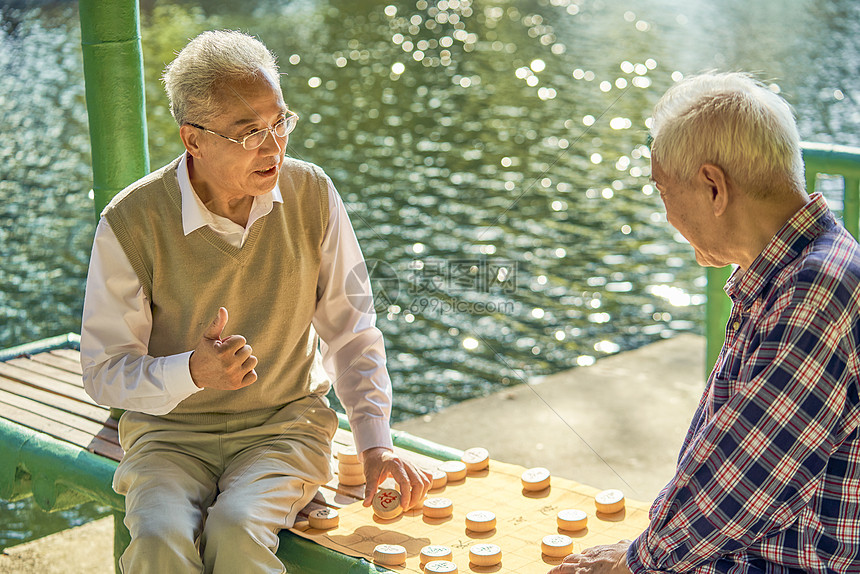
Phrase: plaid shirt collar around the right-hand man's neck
[{"left": 725, "top": 193, "right": 836, "bottom": 303}]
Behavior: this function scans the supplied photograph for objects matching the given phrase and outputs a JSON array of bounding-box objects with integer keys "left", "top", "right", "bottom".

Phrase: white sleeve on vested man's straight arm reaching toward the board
[{"left": 313, "top": 180, "right": 392, "bottom": 452}]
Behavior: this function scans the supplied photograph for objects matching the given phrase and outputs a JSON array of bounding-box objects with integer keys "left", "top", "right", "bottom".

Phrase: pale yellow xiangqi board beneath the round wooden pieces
[{"left": 293, "top": 460, "right": 648, "bottom": 574}]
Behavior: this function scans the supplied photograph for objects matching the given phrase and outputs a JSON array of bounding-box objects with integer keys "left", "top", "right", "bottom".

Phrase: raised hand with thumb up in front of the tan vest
[{"left": 188, "top": 307, "right": 257, "bottom": 391}]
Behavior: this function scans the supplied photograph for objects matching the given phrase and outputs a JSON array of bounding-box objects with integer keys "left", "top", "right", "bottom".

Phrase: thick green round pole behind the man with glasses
[{"left": 79, "top": 0, "right": 149, "bottom": 217}]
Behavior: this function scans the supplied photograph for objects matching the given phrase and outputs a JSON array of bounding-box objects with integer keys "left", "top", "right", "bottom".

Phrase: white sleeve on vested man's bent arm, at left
[{"left": 81, "top": 218, "right": 201, "bottom": 415}]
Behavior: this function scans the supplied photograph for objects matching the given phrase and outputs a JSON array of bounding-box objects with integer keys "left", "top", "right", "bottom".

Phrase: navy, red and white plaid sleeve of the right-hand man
[{"left": 627, "top": 294, "right": 858, "bottom": 573}]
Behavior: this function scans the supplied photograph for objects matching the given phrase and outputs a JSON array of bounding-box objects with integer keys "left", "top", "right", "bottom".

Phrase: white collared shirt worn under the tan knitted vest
[{"left": 81, "top": 154, "right": 391, "bottom": 452}]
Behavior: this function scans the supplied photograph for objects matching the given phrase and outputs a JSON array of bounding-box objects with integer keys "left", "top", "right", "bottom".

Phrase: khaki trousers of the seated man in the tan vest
[{"left": 113, "top": 396, "right": 337, "bottom": 574}]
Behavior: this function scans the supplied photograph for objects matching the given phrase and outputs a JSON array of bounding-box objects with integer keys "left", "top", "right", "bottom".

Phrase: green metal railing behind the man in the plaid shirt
[{"left": 705, "top": 142, "right": 860, "bottom": 377}]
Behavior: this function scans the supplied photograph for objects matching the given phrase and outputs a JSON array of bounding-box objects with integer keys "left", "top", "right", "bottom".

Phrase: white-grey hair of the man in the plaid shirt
[{"left": 651, "top": 73, "right": 805, "bottom": 199}]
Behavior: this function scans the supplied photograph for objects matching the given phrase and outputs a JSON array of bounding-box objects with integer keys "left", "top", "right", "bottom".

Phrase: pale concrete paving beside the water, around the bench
[{"left": 0, "top": 335, "right": 705, "bottom": 574}]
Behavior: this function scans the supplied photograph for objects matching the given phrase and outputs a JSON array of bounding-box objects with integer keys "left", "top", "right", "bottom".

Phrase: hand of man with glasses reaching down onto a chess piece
[{"left": 361, "top": 447, "right": 433, "bottom": 510}]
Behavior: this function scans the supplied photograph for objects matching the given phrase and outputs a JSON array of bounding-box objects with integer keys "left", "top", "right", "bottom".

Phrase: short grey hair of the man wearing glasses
[{"left": 161, "top": 30, "right": 279, "bottom": 126}]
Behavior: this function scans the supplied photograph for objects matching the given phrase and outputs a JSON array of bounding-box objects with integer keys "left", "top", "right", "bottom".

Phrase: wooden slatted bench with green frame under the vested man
[{"left": 0, "top": 334, "right": 462, "bottom": 573}]
